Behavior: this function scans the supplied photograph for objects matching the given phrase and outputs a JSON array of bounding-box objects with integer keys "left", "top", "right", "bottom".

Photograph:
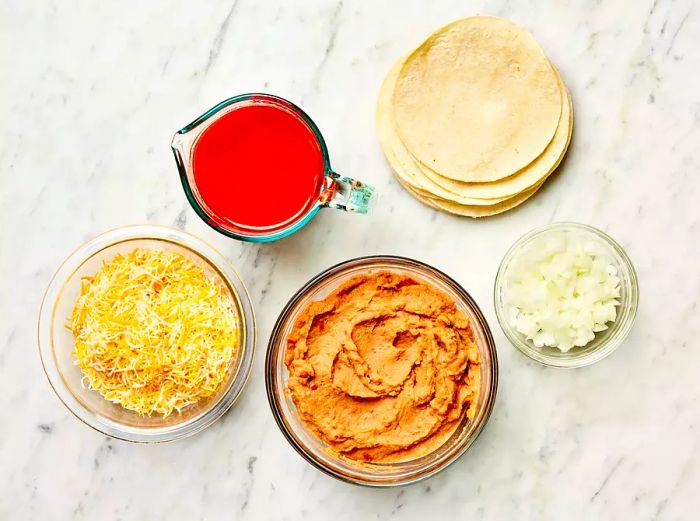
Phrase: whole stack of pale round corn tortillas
[{"left": 377, "top": 16, "right": 573, "bottom": 217}]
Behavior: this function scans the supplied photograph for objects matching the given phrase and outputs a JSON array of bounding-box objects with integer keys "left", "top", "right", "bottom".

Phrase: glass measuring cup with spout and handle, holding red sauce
[{"left": 171, "top": 93, "right": 374, "bottom": 242}]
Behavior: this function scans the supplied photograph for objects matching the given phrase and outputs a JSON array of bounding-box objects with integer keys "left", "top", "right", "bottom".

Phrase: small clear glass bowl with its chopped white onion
[{"left": 494, "top": 222, "right": 639, "bottom": 368}]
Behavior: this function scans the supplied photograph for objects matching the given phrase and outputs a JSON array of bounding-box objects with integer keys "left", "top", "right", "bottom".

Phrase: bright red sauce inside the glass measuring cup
[{"left": 192, "top": 103, "right": 325, "bottom": 231}]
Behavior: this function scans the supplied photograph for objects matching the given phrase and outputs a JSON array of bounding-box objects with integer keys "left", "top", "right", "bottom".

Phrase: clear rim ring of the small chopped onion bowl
[{"left": 493, "top": 221, "right": 639, "bottom": 369}]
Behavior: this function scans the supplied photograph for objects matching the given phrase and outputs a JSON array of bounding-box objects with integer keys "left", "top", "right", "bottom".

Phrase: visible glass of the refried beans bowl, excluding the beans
[{"left": 265, "top": 256, "right": 498, "bottom": 487}]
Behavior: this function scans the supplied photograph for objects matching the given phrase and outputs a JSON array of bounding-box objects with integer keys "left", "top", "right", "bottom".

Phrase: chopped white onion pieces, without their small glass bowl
[{"left": 504, "top": 232, "right": 620, "bottom": 352}]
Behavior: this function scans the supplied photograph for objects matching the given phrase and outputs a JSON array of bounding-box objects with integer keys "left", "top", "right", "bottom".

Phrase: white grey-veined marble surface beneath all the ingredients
[{"left": 0, "top": 0, "right": 700, "bottom": 521}]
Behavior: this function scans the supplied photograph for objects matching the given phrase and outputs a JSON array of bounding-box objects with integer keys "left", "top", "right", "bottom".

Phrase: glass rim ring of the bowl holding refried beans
[{"left": 265, "top": 255, "right": 498, "bottom": 488}]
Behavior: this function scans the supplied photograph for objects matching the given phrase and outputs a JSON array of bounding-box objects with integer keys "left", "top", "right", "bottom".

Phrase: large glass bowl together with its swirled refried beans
[{"left": 265, "top": 256, "right": 498, "bottom": 487}]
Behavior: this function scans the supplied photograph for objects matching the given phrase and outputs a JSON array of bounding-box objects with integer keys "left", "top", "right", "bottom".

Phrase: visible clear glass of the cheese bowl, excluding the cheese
[{"left": 38, "top": 225, "right": 256, "bottom": 443}]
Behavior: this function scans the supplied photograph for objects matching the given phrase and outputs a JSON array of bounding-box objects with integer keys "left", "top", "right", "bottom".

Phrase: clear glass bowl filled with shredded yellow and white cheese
[{"left": 38, "top": 225, "right": 256, "bottom": 443}]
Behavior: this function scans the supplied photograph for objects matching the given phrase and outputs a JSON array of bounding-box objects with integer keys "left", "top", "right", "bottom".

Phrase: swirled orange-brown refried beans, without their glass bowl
[{"left": 285, "top": 271, "right": 480, "bottom": 462}]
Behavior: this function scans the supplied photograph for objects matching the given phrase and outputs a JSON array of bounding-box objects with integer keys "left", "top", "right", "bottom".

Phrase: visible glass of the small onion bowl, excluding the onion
[{"left": 494, "top": 222, "right": 639, "bottom": 368}]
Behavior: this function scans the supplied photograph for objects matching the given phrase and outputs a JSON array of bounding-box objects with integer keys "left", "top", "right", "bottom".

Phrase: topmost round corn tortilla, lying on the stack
[{"left": 393, "top": 16, "right": 562, "bottom": 182}]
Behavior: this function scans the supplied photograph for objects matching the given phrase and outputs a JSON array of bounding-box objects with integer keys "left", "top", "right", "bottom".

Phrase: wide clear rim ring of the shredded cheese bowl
[{"left": 37, "top": 224, "right": 257, "bottom": 444}]
